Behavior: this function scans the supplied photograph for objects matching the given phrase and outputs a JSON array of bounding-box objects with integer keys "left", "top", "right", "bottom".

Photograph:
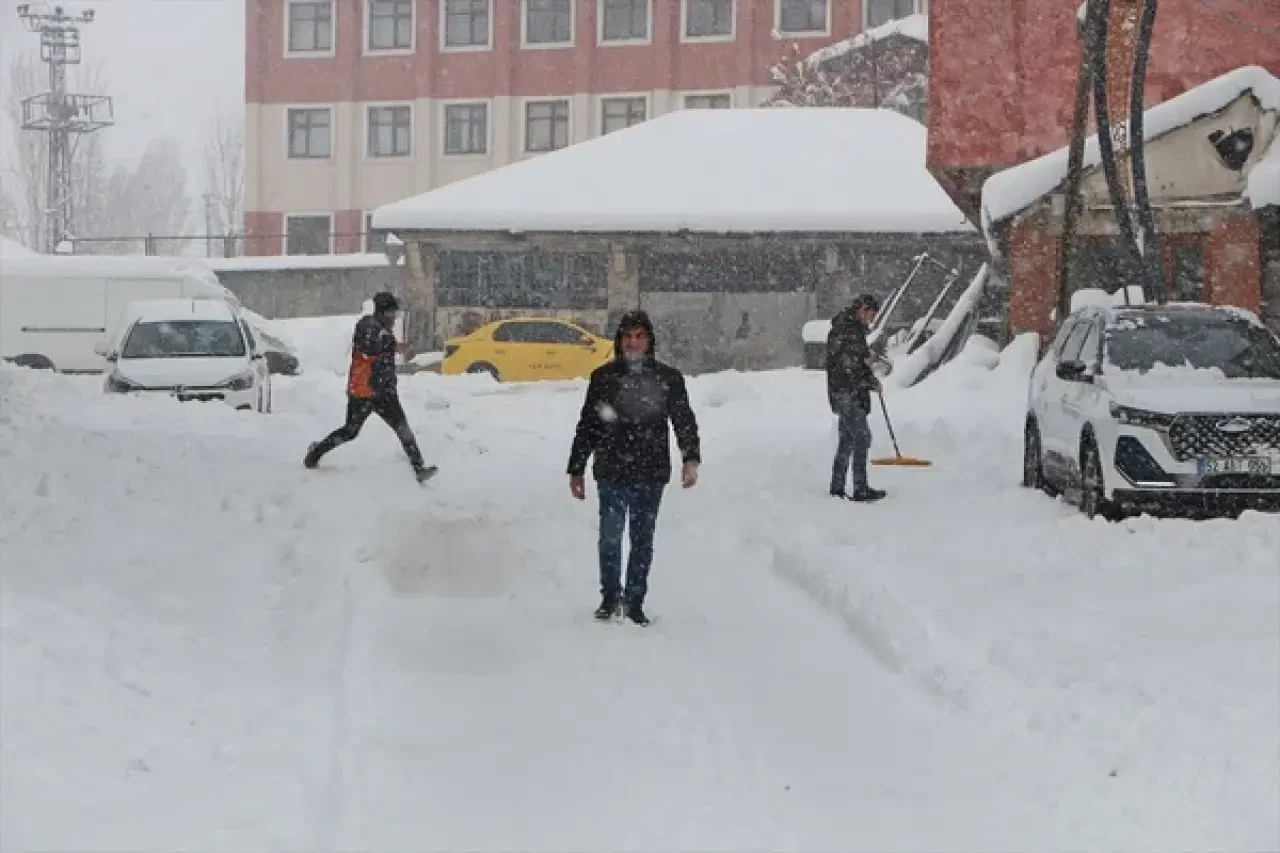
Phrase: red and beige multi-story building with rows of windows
[{"left": 244, "top": 0, "right": 928, "bottom": 255}]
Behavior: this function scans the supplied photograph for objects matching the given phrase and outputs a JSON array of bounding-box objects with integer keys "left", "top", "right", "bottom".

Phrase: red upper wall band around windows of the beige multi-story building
[{"left": 244, "top": 0, "right": 863, "bottom": 104}]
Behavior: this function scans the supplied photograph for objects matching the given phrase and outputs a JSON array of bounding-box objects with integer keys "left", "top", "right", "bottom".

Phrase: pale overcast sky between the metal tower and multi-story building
[{"left": 0, "top": 0, "right": 244, "bottom": 188}]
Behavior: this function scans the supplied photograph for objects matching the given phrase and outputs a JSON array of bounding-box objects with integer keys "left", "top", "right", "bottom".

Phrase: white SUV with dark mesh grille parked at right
[{"left": 1023, "top": 304, "right": 1280, "bottom": 517}]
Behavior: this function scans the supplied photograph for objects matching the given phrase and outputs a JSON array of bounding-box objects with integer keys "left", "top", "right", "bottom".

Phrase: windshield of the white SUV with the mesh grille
[{"left": 1106, "top": 315, "right": 1280, "bottom": 379}]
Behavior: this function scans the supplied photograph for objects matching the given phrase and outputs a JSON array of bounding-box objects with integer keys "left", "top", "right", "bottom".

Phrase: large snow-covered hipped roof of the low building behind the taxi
[{"left": 372, "top": 108, "right": 973, "bottom": 233}]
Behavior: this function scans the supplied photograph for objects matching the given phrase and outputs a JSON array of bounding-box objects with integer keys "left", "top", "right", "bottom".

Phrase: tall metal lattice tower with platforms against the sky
[{"left": 18, "top": 3, "right": 114, "bottom": 254}]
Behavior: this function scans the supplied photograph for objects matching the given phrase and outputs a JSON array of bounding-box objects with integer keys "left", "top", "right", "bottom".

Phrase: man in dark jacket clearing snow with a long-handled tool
[{"left": 827, "top": 293, "right": 884, "bottom": 501}]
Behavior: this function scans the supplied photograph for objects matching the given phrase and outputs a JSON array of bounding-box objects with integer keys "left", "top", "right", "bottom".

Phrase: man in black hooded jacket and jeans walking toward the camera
[{"left": 568, "top": 310, "right": 701, "bottom": 625}]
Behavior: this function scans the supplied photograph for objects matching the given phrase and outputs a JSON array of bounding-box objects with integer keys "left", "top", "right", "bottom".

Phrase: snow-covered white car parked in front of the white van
[{"left": 97, "top": 298, "right": 271, "bottom": 412}]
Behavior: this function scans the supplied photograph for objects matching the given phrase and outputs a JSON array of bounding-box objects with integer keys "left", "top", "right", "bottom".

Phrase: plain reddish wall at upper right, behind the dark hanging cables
[{"left": 928, "top": 0, "right": 1280, "bottom": 169}]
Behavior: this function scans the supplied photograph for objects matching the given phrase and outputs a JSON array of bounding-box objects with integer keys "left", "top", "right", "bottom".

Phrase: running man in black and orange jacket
[{"left": 302, "top": 293, "right": 436, "bottom": 483}]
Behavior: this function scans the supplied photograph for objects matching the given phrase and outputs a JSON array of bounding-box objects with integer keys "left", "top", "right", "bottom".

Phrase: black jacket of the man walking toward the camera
[{"left": 568, "top": 347, "right": 701, "bottom": 483}]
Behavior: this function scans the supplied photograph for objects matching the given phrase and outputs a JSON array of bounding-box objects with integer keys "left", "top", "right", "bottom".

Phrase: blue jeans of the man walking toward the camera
[{"left": 596, "top": 482, "right": 666, "bottom": 605}]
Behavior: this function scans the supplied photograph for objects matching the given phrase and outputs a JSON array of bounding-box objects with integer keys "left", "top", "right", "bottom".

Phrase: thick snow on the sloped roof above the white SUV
[{"left": 982, "top": 65, "right": 1280, "bottom": 228}]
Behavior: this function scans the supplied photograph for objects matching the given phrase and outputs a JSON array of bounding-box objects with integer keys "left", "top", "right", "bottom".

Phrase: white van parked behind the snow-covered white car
[{"left": 0, "top": 254, "right": 241, "bottom": 373}]
